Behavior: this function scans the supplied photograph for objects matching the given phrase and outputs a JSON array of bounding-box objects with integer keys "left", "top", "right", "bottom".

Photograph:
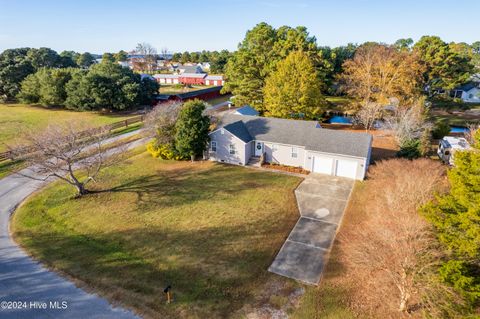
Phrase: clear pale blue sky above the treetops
[{"left": 0, "top": 0, "right": 480, "bottom": 53}]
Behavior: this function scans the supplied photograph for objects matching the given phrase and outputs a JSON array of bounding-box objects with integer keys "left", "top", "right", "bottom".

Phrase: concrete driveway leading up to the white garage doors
[{"left": 268, "top": 174, "right": 354, "bottom": 285}]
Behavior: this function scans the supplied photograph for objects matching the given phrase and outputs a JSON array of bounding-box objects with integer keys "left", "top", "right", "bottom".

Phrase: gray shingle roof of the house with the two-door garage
[{"left": 220, "top": 114, "right": 372, "bottom": 158}]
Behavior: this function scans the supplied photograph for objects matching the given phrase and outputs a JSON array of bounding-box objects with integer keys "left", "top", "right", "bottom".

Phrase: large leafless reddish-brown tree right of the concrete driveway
[{"left": 341, "top": 159, "right": 460, "bottom": 317}]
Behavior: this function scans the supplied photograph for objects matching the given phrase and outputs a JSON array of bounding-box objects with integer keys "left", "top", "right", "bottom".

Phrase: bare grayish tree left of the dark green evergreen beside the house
[{"left": 145, "top": 102, "right": 181, "bottom": 145}]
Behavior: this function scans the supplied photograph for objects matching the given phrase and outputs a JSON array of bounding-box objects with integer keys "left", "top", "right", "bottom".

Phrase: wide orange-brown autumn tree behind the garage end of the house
[{"left": 339, "top": 43, "right": 423, "bottom": 105}]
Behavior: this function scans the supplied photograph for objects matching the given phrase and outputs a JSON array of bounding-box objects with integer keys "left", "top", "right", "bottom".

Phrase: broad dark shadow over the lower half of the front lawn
[{"left": 17, "top": 220, "right": 284, "bottom": 318}]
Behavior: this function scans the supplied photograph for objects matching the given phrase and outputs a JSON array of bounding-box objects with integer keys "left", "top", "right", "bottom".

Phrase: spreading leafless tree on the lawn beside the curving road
[{"left": 10, "top": 123, "right": 119, "bottom": 196}]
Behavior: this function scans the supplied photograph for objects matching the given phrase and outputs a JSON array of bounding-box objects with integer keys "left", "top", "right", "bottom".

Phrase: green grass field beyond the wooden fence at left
[{"left": 0, "top": 104, "right": 130, "bottom": 152}]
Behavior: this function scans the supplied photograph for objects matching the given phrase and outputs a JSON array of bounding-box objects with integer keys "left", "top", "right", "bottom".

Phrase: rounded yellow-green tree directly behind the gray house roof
[{"left": 264, "top": 51, "right": 326, "bottom": 119}]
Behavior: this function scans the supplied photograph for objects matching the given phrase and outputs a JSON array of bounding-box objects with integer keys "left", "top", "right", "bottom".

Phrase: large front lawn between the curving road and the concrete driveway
[{"left": 12, "top": 153, "right": 301, "bottom": 318}]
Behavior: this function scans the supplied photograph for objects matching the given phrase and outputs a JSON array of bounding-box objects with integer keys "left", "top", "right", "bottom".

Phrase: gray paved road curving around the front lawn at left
[{"left": 0, "top": 132, "right": 144, "bottom": 319}]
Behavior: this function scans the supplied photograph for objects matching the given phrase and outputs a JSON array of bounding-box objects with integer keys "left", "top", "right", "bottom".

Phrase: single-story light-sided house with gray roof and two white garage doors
[{"left": 205, "top": 114, "right": 372, "bottom": 180}]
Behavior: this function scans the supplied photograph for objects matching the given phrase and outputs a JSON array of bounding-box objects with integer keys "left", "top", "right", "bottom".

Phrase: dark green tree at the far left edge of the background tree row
[{"left": 0, "top": 48, "right": 35, "bottom": 100}]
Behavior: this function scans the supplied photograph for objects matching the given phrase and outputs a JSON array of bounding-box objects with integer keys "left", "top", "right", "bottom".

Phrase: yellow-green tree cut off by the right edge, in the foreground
[{"left": 422, "top": 130, "right": 480, "bottom": 306}]
